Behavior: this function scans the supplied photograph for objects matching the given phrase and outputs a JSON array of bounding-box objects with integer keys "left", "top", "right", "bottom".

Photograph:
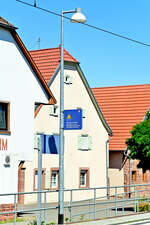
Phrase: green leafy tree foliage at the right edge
[{"left": 126, "top": 111, "right": 150, "bottom": 171}]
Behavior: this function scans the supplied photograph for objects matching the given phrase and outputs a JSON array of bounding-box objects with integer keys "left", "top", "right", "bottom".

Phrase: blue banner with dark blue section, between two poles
[{"left": 41, "top": 134, "right": 59, "bottom": 154}]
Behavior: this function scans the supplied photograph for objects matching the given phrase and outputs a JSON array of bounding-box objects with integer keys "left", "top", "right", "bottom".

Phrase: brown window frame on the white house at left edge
[{"left": 0, "top": 101, "right": 11, "bottom": 134}]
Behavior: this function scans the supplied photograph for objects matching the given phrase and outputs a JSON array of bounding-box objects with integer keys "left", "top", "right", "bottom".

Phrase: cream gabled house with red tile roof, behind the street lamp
[{"left": 24, "top": 47, "right": 112, "bottom": 203}]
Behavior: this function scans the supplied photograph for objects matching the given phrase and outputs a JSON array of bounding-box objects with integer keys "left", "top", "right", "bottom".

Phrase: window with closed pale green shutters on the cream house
[{"left": 78, "top": 134, "right": 92, "bottom": 151}]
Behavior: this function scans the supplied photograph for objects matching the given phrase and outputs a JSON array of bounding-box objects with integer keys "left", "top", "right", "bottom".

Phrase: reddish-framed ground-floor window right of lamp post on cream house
[{"left": 79, "top": 168, "right": 89, "bottom": 188}]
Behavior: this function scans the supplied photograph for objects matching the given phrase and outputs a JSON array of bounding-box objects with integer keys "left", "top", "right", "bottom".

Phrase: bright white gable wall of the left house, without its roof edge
[{"left": 0, "top": 28, "right": 51, "bottom": 202}]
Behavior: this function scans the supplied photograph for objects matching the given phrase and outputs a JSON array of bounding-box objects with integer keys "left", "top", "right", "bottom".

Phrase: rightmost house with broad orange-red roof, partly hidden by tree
[{"left": 92, "top": 84, "right": 150, "bottom": 193}]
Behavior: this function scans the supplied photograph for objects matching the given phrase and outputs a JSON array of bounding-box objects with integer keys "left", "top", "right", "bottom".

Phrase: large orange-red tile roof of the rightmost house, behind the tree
[{"left": 92, "top": 84, "right": 150, "bottom": 150}]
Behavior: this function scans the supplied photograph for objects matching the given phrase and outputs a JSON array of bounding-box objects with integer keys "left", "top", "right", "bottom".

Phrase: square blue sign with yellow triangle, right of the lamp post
[{"left": 64, "top": 109, "right": 82, "bottom": 130}]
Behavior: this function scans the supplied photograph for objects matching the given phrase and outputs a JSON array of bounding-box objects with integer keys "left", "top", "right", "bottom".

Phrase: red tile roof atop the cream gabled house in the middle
[{"left": 29, "top": 47, "right": 78, "bottom": 83}]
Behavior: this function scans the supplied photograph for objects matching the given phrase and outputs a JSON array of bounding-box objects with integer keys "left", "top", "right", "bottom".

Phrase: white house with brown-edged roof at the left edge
[{"left": 0, "top": 17, "right": 56, "bottom": 216}]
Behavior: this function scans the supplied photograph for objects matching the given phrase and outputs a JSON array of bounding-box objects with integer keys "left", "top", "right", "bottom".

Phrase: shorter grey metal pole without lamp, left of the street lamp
[{"left": 37, "top": 135, "right": 42, "bottom": 225}]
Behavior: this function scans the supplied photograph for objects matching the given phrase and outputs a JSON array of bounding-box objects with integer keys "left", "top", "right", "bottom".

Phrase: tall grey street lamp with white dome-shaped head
[{"left": 58, "top": 8, "right": 86, "bottom": 224}]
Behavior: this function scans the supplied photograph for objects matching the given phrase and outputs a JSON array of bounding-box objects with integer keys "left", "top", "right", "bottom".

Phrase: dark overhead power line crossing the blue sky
[{"left": 16, "top": 0, "right": 150, "bottom": 47}]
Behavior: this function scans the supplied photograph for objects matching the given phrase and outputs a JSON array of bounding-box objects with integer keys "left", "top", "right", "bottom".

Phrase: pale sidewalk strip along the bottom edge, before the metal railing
[{"left": 5, "top": 213, "right": 150, "bottom": 225}]
